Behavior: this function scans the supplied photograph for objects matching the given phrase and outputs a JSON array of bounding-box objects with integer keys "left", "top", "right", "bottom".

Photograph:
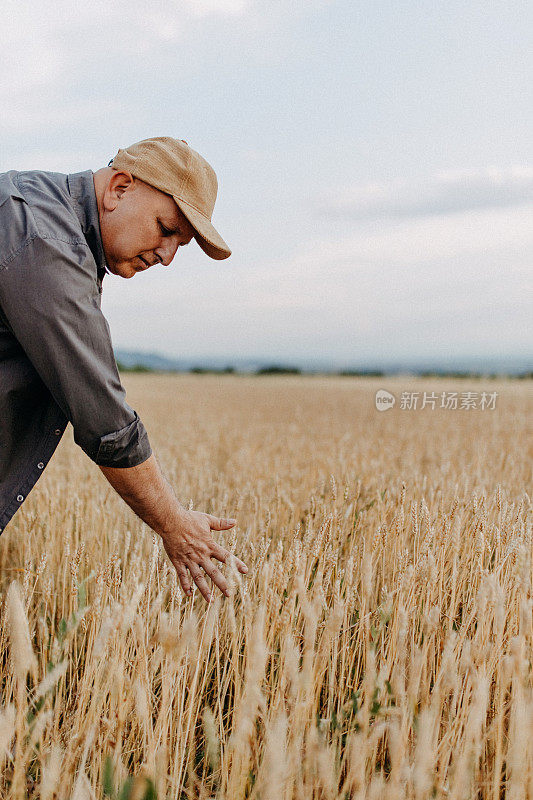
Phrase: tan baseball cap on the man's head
[{"left": 109, "top": 136, "right": 231, "bottom": 260}]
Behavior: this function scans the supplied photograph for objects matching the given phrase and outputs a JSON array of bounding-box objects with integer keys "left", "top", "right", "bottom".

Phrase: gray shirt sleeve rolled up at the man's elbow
[{"left": 0, "top": 236, "right": 152, "bottom": 467}]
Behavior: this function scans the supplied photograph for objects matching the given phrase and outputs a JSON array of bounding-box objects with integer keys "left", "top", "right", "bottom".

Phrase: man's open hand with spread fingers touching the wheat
[{"left": 162, "top": 511, "right": 248, "bottom": 602}]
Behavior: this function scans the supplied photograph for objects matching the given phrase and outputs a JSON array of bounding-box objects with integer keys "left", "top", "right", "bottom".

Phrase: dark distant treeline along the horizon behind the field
[{"left": 117, "top": 361, "right": 533, "bottom": 380}]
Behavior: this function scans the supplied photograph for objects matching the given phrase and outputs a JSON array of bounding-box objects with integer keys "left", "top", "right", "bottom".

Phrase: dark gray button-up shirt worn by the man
[{"left": 0, "top": 170, "right": 152, "bottom": 532}]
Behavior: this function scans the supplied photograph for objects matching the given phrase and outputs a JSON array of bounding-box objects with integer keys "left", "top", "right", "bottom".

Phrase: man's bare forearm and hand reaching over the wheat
[{"left": 100, "top": 453, "right": 248, "bottom": 601}]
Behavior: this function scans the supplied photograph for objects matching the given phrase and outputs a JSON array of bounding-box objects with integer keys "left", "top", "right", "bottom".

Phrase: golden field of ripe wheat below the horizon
[{"left": 0, "top": 375, "right": 533, "bottom": 800}]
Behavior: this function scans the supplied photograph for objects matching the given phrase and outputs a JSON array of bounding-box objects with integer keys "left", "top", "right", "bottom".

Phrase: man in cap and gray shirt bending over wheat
[{"left": 0, "top": 137, "right": 248, "bottom": 601}]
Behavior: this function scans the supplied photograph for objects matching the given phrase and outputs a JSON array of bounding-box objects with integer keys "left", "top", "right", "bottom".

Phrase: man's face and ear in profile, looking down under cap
[{"left": 100, "top": 170, "right": 194, "bottom": 278}]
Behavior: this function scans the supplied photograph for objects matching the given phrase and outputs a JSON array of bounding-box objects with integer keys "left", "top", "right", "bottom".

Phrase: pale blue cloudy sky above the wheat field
[{"left": 0, "top": 0, "right": 533, "bottom": 365}]
